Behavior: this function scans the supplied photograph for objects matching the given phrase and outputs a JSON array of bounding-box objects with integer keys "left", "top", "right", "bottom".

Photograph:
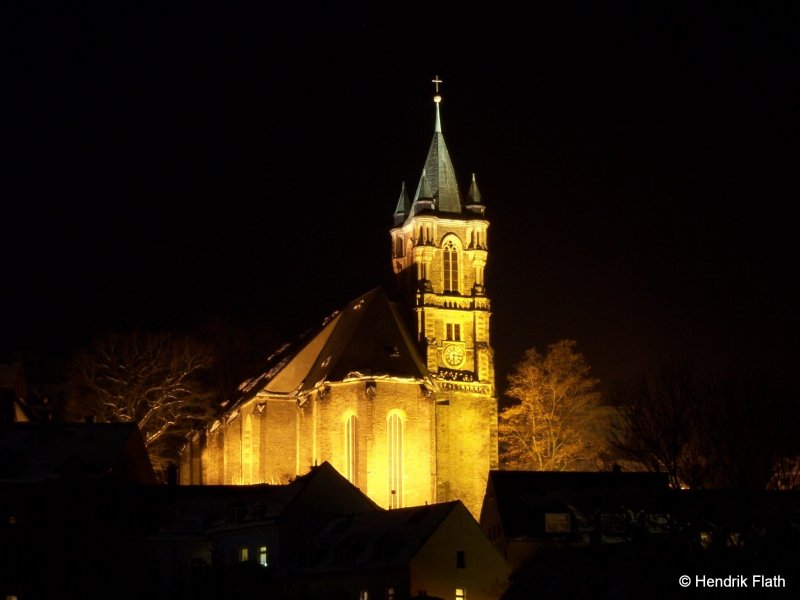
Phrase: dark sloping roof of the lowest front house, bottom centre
[{"left": 289, "top": 500, "right": 462, "bottom": 574}]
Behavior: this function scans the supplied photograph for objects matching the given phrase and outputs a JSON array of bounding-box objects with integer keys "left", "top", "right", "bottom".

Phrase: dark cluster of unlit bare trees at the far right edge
[{"left": 611, "top": 363, "right": 800, "bottom": 489}]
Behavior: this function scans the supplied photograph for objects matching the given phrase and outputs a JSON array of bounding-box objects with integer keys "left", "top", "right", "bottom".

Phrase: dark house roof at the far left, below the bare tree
[{"left": 0, "top": 422, "right": 155, "bottom": 484}]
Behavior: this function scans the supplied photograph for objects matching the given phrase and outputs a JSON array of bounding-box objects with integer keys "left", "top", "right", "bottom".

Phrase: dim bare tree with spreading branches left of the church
[{"left": 67, "top": 332, "right": 213, "bottom": 472}]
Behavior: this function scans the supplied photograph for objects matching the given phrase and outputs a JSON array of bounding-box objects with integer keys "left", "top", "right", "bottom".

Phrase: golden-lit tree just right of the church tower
[{"left": 498, "top": 340, "right": 600, "bottom": 471}]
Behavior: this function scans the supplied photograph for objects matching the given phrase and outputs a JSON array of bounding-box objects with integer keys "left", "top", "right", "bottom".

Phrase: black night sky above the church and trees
[{"left": 6, "top": 2, "right": 800, "bottom": 398}]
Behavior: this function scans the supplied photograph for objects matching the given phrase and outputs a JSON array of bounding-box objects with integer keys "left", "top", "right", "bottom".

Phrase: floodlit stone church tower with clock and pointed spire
[{"left": 391, "top": 77, "right": 497, "bottom": 510}]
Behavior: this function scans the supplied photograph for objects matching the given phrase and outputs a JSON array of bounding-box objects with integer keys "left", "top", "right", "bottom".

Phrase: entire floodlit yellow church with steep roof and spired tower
[{"left": 180, "top": 78, "right": 498, "bottom": 518}]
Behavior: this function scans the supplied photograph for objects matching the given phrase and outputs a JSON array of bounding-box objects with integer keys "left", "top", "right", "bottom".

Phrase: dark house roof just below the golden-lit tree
[{"left": 481, "top": 471, "right": 669, "bottom": 538}]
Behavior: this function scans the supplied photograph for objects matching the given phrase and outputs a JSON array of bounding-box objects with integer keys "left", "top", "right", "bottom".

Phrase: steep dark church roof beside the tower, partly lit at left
[{"left": 231, "top": 287, "right": 428, "bottom": 401}]
